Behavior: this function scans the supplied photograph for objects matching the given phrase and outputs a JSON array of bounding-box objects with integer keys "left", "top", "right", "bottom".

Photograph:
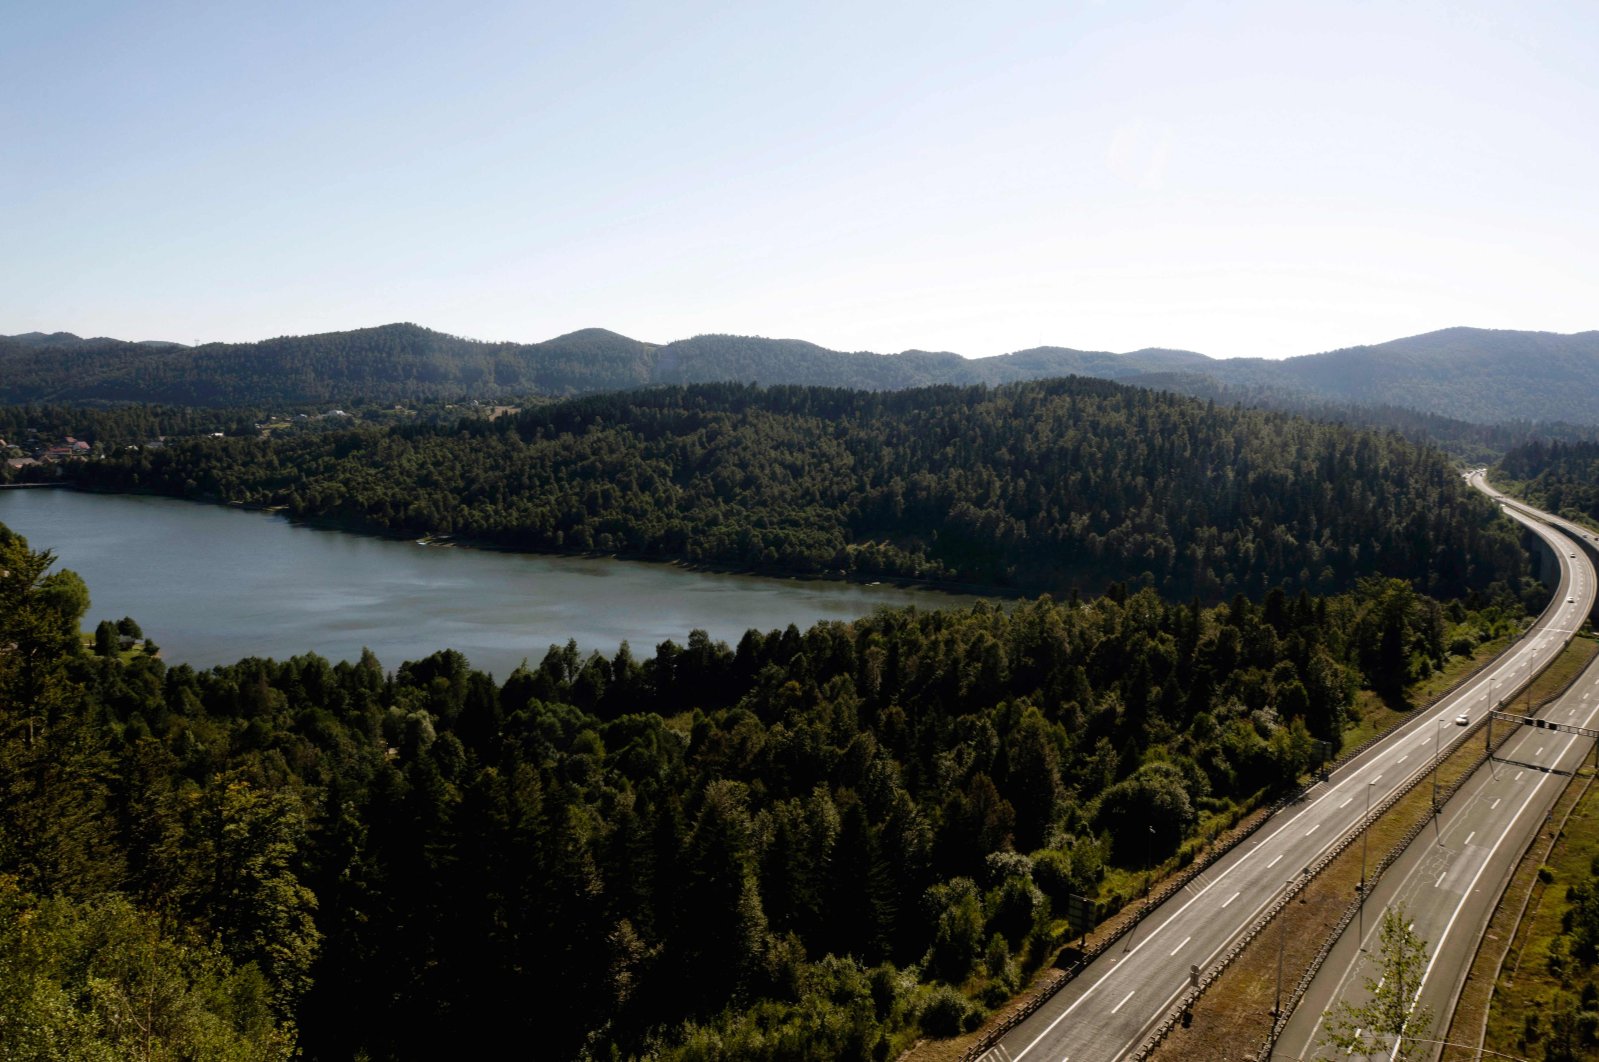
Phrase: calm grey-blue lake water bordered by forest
[{"left": 0, "top": 489, "right": 972, "bottom": 678}]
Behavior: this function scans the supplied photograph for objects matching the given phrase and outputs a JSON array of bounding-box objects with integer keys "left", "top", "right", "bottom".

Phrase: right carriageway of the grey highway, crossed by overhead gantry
[{"left": 1273, "top": 475, "right": 1599, "bottom": 1059}]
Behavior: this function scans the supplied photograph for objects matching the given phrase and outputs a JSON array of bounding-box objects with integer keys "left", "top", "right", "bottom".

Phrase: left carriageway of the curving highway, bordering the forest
[{"left": 983, "top": 483, "right": 1594, "bottom": 1062}]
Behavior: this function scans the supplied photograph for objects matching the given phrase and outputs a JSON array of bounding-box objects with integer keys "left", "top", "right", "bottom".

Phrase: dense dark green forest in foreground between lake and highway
[{"left": 0, "top": 529, "right": 1521, "bottom": 1060}]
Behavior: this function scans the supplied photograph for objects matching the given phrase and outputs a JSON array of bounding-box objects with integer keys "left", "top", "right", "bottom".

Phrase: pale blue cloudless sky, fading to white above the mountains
[{"left": 0, "top": 0, "right": 1599, "bottom": 357}]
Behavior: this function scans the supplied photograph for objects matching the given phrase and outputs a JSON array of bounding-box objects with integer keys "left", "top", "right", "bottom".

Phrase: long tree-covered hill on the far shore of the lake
[{"left": 72, "top": 377, "right": 1524, "bottom": 600}]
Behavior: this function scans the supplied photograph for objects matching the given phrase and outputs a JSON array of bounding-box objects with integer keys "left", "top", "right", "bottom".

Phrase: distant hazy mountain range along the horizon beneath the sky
[{"left": 0, "top": 325, "right": 1599, "bottom": 425}]
